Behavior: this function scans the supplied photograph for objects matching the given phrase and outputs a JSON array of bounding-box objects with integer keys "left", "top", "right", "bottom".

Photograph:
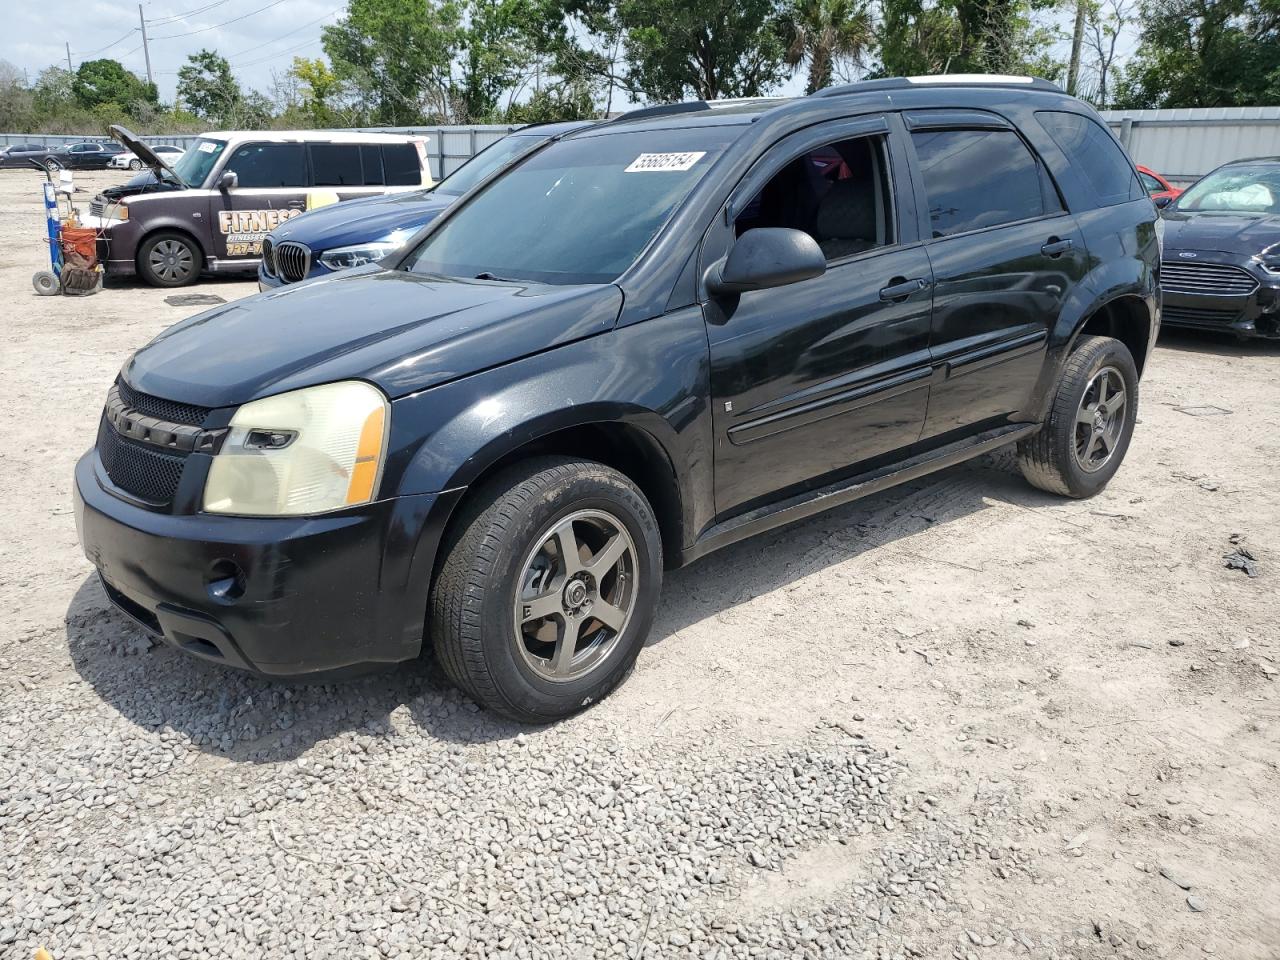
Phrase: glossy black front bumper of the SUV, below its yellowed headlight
[{"left": 76, "top": 451, "right": 461, "bottom": 680}]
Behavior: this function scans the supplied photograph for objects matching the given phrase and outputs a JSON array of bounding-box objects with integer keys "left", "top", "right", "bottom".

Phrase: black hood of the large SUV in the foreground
[{"left": 122, "top": 264, "right": 622, "bottom": 407}]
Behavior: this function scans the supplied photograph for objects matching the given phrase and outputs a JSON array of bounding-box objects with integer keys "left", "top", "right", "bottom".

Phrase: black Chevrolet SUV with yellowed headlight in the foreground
[{"left": 76, "top": 77, "right": 1160, "bottom": 721}]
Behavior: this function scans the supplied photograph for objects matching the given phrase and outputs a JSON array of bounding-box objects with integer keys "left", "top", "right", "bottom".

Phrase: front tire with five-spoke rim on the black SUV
[{"left": 428, "top": 457, "right": 662, "bottom": 723}]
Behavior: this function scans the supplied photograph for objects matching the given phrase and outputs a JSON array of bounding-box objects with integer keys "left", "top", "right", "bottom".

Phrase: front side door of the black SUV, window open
[{"left": 703, "top": 115, "right": 931, "bottom": 516}]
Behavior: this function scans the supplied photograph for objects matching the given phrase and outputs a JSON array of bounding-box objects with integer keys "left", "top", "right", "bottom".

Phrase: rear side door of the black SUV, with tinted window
[{"left": 904, "top": 110, "right": 1087, "bottom": 440}]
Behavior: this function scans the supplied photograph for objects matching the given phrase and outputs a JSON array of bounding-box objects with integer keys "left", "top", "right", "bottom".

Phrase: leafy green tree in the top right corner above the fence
[{"left": 1116, "top": 0, "right": 1280, "bottom": 108}]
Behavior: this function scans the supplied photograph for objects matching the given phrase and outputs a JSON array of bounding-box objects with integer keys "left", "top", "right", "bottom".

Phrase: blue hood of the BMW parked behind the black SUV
[{"left": 271, "top": 189, "right": 457, "bottom": 251}]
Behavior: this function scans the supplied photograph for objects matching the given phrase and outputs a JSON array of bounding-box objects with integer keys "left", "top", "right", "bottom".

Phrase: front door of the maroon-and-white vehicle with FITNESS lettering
[{"left": 209, "top": 142, "right": 310, "bottom": 262}]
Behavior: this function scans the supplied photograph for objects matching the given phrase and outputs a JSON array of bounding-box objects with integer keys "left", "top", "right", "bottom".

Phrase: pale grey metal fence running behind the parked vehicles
[{"left": 0, "top": 106, "right": 1280, "bottom": 183}]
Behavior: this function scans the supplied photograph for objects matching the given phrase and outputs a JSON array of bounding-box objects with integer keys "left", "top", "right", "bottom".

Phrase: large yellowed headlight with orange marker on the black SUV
[{"left": 204, "top": 380, "right": 390, "bottom": 517}]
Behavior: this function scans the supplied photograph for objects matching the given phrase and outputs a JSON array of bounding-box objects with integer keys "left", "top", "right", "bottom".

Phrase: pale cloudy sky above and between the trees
[{"left": 0, "top": 0, "right": 1133, "bottom": 110}]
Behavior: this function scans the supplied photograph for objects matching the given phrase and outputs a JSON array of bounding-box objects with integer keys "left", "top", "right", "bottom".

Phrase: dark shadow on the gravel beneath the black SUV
[{"left": 65, "top": 452, "right": 1039, "bottom": 763}]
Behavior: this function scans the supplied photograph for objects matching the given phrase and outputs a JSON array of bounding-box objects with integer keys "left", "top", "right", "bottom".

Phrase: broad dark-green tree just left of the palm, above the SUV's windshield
[{"left": 617, "top": 0, "right": 785, "bottom": 101}]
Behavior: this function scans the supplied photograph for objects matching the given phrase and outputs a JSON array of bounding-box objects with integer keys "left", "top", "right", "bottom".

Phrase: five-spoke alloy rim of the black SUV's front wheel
[{"left": 513, "top": 509, "right": 639, "bottom": 682}]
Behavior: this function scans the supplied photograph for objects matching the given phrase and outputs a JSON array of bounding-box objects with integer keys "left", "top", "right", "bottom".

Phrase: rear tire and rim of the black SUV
[{"left": 1018, "top": 337, "right": 1138, "bottom": 498}]
